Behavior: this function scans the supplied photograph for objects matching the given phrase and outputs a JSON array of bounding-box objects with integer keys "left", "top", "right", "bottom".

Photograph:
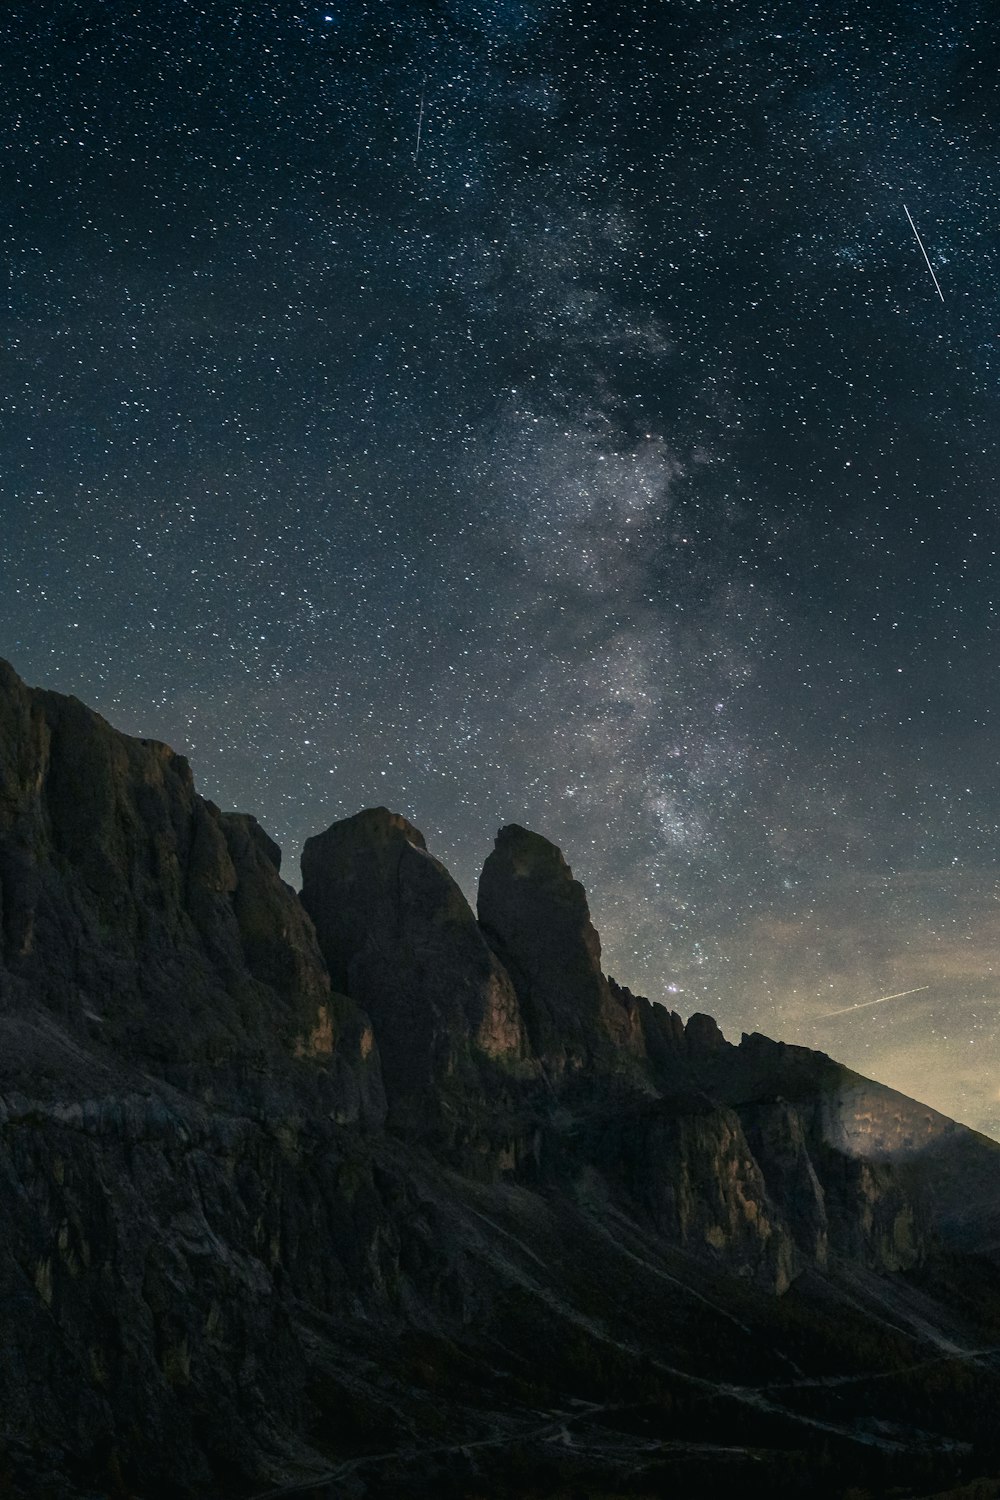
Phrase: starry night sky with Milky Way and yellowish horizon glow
[{"left": 0, "top": 0, "right": 1000, "bottom": 1136}]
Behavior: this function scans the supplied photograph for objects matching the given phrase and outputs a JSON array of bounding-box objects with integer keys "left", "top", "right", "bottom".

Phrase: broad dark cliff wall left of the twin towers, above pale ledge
[{"left": 0, "top": 665, "right": 382, "bottom": 1118}]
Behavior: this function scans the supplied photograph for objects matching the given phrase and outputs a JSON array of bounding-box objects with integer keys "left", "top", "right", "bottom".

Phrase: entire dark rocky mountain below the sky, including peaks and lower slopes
[{"left": 0, "top": 665, "right": 1000, "bottom": 1500}]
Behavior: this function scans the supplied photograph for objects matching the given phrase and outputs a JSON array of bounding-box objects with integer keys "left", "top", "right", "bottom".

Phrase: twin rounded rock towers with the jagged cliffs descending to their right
[{"left": 301, "top": 809, "right": 921, "bottom": 1292}]
